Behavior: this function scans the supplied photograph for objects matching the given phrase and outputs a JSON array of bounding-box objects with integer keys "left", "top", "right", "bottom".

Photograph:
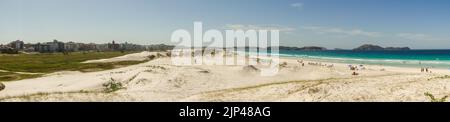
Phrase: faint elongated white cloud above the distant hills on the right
[{"left": 302, "top": 26, "right": 382, "bottom": 37}]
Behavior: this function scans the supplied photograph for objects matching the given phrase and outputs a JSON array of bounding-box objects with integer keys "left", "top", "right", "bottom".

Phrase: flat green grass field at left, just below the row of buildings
[{"left": 0, "top": 52, "right": 138, "bottom": 73}]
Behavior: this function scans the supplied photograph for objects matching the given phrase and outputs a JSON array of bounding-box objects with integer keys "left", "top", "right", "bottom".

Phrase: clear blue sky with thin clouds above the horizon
[{"left": 0, "top": 0, "right": 450, "bottom": 49}]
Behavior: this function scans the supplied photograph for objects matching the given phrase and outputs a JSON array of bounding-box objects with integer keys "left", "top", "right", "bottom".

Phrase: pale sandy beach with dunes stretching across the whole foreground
[{"left": 0, "top": 52, "right": 450, "bottom": 102}]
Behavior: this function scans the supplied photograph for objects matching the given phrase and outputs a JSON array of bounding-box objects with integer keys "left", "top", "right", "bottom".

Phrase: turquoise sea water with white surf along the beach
[{"left": 279, "top": 50, "right": 450, "bottom": 70}]
